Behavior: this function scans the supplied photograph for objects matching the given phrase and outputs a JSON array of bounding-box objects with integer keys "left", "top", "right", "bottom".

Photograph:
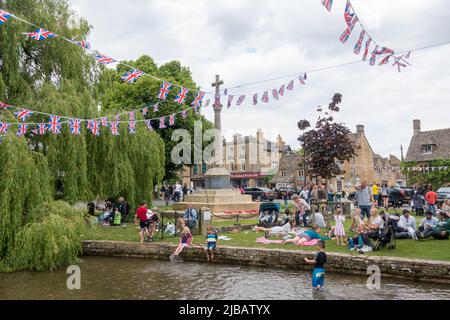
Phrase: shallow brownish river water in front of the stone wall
[{"left": 0, "top": 257, "right": 450, "bottom": 300}]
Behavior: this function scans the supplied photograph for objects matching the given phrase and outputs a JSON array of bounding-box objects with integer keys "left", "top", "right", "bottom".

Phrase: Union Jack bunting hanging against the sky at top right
[{"left": 321, "top": 0, "right": 411, "bottom": 72}]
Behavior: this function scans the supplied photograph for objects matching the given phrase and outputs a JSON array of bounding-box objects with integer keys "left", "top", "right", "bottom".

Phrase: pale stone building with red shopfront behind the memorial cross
[{"left": 182, "top": 129, "right": 291, "bottom": 189}]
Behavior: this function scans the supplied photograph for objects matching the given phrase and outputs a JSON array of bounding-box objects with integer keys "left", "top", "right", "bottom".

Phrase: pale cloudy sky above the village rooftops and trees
[{"left": 69, "top": 0, "right": 450, "bottom": 156}]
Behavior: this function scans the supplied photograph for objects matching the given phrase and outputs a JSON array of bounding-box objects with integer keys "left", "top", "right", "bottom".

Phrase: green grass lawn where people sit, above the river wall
[{"left": 83, "top": 212, "right": 450, "bottom": 261}]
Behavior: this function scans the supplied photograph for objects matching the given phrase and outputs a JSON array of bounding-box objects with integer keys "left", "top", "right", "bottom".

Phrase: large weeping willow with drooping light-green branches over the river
[{"left": 0, "top": 0, "right": 165, "bottom": 271}]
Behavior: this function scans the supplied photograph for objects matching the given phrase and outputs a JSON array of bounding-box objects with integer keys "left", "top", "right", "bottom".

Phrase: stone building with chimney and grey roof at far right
[{"left": 405, "top": 120, "right": 450, "bottom": 166}]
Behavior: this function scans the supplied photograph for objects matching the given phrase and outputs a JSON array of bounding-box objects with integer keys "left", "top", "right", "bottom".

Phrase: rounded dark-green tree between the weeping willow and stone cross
[{"left": 97, "top": 55, "right": 213, "bottom": 181}]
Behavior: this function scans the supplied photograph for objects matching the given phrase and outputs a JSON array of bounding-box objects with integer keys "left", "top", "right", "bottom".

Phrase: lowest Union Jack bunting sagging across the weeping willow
[{"left": 0, "top": 102, "right": 199, "bottom": 141}]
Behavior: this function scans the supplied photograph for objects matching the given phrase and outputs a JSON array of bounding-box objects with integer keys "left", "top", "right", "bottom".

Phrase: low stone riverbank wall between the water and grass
[{"left": 83, "top": 241, "right": 450, "bottom": 285}]
